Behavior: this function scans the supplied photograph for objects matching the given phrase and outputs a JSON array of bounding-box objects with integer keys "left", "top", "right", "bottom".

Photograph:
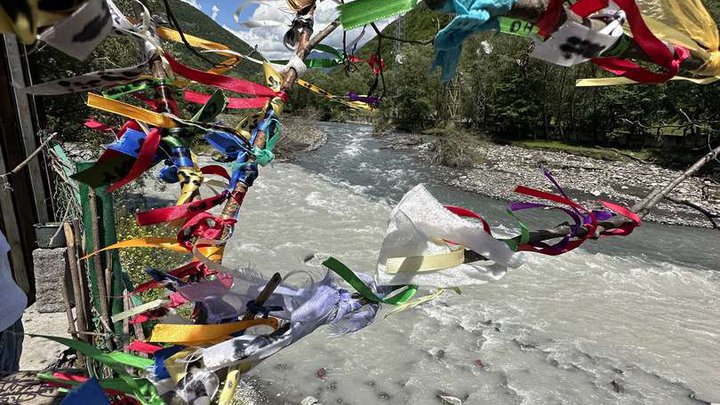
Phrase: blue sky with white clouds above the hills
[{"left": 182, "top": 0, "right": 392, "bottom": 59}]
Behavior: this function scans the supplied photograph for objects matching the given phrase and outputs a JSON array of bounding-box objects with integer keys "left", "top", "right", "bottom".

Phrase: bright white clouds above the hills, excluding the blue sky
[{"left": 223, "top": 1, "right": 392, "bottom": 59}]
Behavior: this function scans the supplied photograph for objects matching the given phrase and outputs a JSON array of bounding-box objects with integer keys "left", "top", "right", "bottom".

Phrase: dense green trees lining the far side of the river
[{"left": 304, "top": 0, "right": 720, "bottom": 172}]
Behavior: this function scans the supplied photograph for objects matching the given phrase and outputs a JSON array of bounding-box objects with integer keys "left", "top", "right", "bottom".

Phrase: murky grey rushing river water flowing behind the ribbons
[{"left": 146, "top": 124, "right": 720, "bottom": 404}]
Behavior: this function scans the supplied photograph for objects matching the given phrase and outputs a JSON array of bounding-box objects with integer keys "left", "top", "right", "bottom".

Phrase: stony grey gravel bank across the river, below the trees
[{"left": 383, "top": 134, "right": 720, "bottom": 228}]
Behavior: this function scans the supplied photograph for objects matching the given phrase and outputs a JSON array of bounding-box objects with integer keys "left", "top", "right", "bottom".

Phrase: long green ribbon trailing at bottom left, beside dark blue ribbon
[{"left": 30, "top": 334, "right": 165, "bottom": 405}]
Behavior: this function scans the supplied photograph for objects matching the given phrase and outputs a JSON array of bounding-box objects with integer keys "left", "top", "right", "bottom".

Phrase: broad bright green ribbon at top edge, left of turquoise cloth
[{"left": 338, "top": 0, "right": 418, "bottom": 30}]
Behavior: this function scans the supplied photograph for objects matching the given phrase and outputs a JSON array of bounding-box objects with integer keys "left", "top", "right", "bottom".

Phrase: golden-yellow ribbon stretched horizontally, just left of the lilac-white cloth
[{"left": 150, "top": 318, "right": 278, "bottom": 345}]
